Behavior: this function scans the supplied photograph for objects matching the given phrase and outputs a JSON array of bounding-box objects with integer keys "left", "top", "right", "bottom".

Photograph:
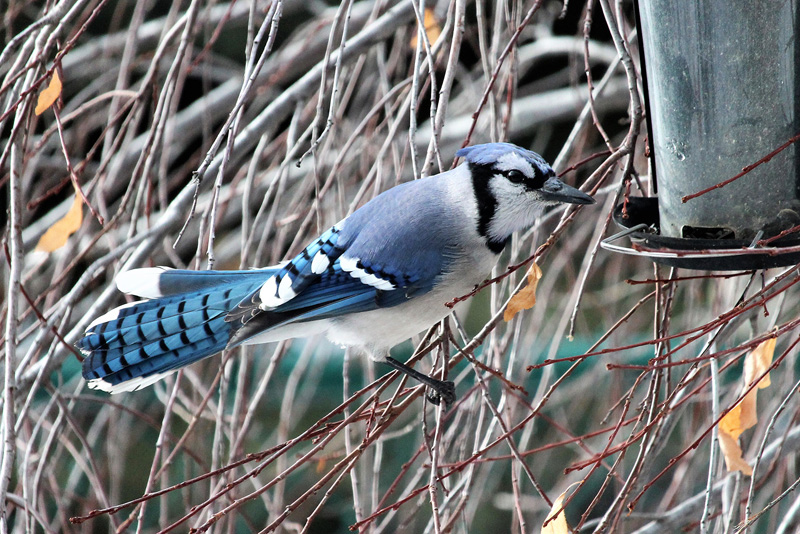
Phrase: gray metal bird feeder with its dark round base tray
[{"left": 604, "top": 0, "right": 800, "bottom": 270}]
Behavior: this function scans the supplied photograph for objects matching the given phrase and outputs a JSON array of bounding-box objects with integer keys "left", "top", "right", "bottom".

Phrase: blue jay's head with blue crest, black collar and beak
[{"left": 456, "top": 143, "right": 594, "bottom": 250}]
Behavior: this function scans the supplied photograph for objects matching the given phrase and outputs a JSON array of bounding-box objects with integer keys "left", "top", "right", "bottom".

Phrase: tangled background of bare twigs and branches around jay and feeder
[{"left": 0, "top": 0, "right": 800, "bottom": 533}]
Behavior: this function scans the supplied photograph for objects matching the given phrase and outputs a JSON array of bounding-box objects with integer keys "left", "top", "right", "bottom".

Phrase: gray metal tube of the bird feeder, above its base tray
[{"left": 639, "top": 0, "right": 800, "bottom": 239}]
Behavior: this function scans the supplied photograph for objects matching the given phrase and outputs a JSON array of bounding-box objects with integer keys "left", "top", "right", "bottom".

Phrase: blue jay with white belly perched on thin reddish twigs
[{"left": 76, "top": 143, "right": 594, "bottom": 405}]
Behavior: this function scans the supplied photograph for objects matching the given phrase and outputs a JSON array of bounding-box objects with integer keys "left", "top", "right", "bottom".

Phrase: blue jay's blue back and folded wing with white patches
[{"left": 226, "top": 178, "right": 457, "bottom": 347}]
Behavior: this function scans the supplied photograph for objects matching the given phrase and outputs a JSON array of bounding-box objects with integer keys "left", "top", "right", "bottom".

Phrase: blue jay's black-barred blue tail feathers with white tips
[{"left": 77, "top": 268, "right": 275, "bottom": 393}]
